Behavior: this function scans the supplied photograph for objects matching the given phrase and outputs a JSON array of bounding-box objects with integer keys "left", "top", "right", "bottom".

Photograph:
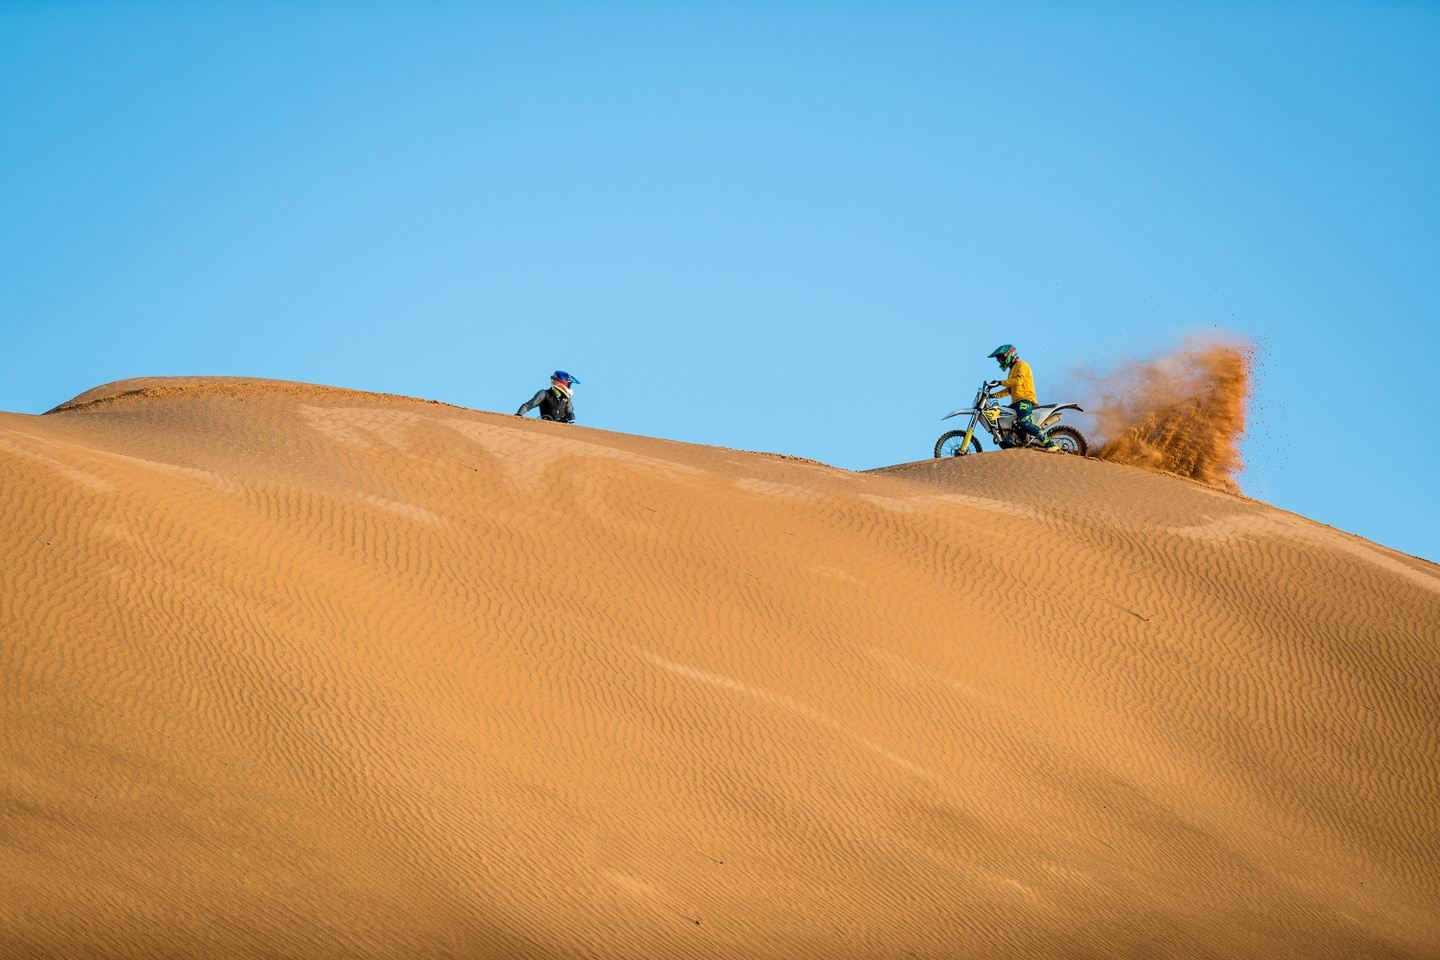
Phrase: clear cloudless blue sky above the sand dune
[{"left": 0, "top": 0, "right": 1440, "bottom": 560}]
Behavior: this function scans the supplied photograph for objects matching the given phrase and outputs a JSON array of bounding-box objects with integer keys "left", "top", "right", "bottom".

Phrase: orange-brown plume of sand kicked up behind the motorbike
[{"left": 1090, "top": 338, "right": 1253, "bottom": 492}]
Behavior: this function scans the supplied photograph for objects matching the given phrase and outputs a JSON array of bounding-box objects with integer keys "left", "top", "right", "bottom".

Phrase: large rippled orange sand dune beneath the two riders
[{"left": 0, "top": 381, "right": 1440, "bottom": 957}]
